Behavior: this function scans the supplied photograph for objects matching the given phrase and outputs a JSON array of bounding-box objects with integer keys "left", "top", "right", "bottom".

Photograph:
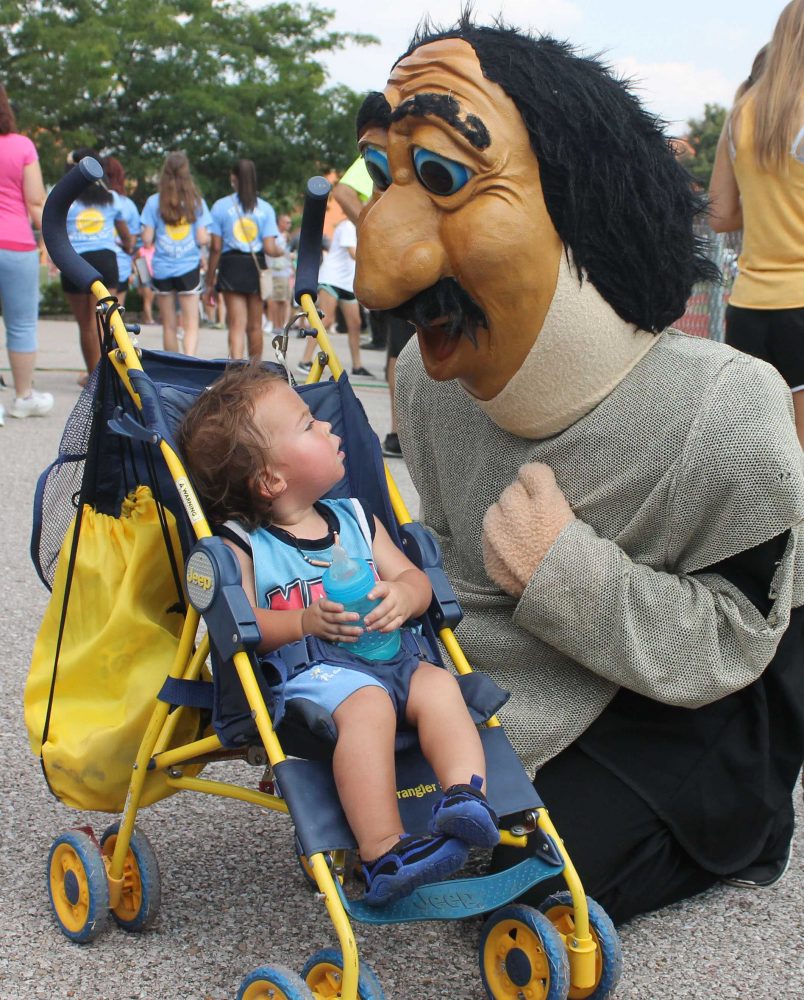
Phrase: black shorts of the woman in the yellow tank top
[{"left": 726, "top": 306, "right": 804, "bottom": 389}]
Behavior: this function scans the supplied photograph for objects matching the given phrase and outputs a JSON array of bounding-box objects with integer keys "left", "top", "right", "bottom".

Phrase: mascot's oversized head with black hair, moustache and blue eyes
[{"left": 355, "top": 16, "right": 714, "bottom": 399}]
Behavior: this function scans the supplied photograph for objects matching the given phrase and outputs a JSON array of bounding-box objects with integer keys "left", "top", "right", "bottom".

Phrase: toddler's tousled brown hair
[{"left": 178, "top": 365, "right": 284, "bottom": 531}]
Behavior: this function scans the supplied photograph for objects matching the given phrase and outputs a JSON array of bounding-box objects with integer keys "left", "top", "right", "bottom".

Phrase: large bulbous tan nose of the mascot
[{"left": 355, "top": 184, "right": 450, "bottom": 309}]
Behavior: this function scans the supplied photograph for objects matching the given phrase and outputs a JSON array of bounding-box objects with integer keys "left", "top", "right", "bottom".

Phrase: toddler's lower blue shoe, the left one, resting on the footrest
[{"left": 362, "top": 834, "right": 469, "bottom": 906}]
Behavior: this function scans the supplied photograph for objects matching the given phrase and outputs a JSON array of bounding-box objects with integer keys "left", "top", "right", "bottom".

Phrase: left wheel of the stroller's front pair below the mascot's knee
[{"left": 479, "top": 904, "right": 570, "bottom": 1000}]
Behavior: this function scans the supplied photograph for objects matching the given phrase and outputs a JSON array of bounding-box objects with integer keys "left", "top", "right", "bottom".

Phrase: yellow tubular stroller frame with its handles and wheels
[{"left": 43, "top": 159, "right": 620, "bottom": 1000}]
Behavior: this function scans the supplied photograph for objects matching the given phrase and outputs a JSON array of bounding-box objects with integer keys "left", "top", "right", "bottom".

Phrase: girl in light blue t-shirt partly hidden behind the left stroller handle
[{"left": 61, "top": 148, "right": 132, "bottom": 385}]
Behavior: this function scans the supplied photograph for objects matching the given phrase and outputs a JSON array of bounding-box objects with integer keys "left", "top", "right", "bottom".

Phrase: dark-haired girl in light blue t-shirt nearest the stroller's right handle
[{"left": 204, "top": 160, "right": 284, "bottom": 361}]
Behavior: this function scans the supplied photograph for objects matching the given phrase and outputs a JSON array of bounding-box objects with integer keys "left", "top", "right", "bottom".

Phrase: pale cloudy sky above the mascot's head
[{"left": 320, "top": 0, "right": 785, "bottom": 135}]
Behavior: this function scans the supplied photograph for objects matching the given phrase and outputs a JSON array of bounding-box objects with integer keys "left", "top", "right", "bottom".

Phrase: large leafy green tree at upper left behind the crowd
[{"left": 0, "top": 0, "right": 376, "bottom": 204}]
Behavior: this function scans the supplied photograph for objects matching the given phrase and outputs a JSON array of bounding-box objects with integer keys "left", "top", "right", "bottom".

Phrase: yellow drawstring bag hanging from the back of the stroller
[{"left": 25, "top": 486, "right": 198, "bottom": 812}]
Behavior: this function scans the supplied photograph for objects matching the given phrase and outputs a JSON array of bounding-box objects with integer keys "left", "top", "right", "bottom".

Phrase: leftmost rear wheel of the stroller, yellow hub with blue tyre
[{"left": 47, "top": 830, "right": 109, "bottom": 944}]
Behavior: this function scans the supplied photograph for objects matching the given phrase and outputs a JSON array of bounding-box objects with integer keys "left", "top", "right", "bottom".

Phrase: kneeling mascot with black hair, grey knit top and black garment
[{"left": 355, "top": 17, "right": 804, "bottom": 921}]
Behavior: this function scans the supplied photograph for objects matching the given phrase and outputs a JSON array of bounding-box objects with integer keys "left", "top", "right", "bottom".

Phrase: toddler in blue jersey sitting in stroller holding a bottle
[{"left": 179, "top": 366, "right": 500, "bottom": 904}]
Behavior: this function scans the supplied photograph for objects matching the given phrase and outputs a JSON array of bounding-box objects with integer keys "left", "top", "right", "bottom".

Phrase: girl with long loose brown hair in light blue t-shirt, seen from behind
[{"left": 142, "top": 153, "right": 212, "bottom": 354}]
